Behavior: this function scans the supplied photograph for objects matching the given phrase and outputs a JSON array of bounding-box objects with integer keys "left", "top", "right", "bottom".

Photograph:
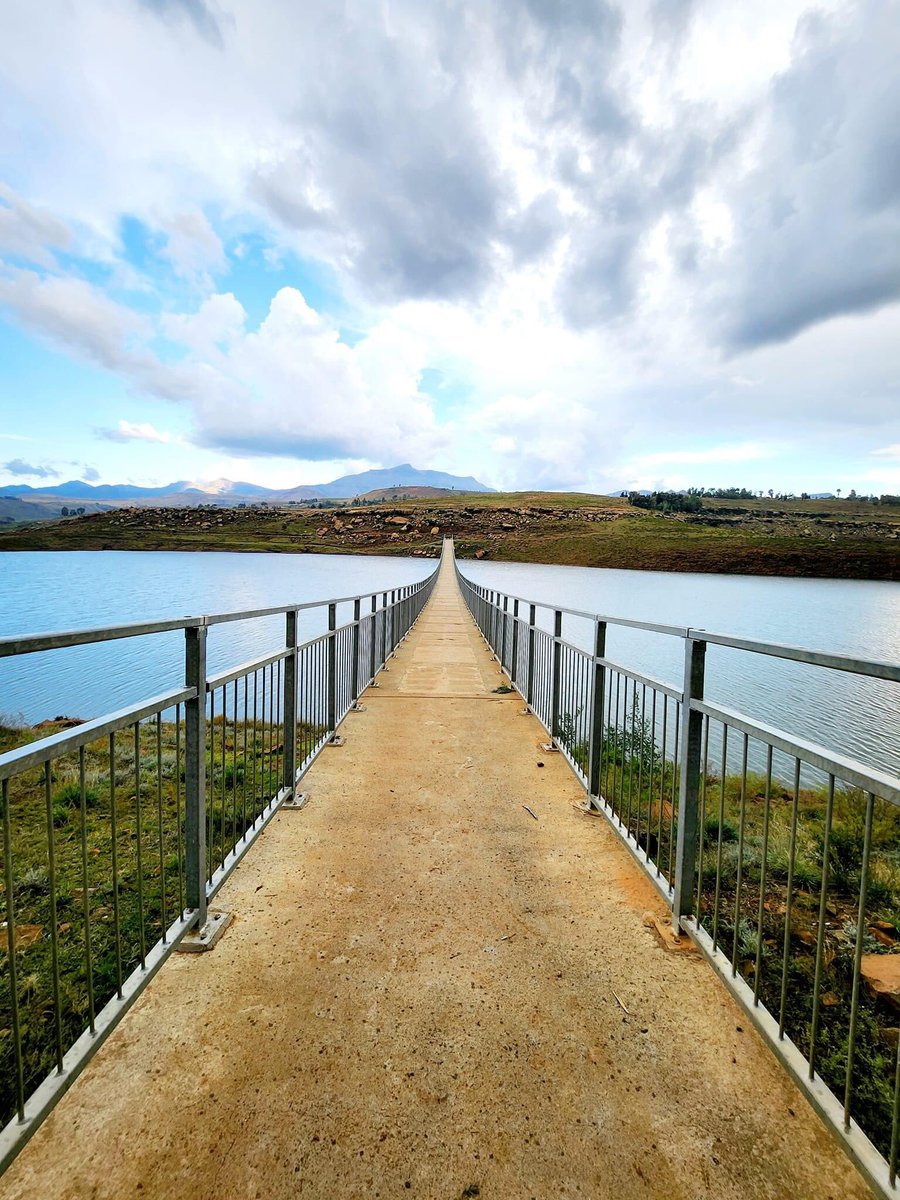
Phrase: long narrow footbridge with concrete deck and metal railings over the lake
[{"left": 0, "top": 544, "right": 896, "bottom": 1200}]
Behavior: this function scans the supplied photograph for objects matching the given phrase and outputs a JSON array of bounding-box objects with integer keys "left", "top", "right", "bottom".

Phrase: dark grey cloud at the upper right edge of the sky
[{"left": 714, "top": 0, "right": 900, "bottom": 347}]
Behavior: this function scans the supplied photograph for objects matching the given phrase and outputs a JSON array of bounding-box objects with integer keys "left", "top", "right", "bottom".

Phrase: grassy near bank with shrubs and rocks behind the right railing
[{"left": 562, "top": 716, "right": 900, "bottom": 1154}]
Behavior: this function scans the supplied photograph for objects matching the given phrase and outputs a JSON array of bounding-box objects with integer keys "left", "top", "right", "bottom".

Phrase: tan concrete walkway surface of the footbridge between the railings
[{"left": 0, "top": 549, "right": 869, "bottom": 1200}]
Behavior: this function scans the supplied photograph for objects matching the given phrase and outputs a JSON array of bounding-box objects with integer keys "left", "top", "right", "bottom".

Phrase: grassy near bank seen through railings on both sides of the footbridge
[{"left": 7, "top": 700, "right": 900, "bottom": 1151}]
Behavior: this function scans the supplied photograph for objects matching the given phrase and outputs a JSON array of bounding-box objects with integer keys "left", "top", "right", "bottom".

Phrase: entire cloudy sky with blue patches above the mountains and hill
[{"left": 0, "top": 0, "right": 900, "bottom": 494}]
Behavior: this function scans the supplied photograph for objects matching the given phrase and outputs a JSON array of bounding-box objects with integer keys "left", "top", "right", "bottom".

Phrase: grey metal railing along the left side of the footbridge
[{"left": 0, "top": 571, "right": 437, "bottom": 1171}]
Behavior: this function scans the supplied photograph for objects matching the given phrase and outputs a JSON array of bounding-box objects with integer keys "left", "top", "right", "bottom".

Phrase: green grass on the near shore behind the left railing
[{"left": 0, "top": 716, "right": 318, "bottom": 1122}]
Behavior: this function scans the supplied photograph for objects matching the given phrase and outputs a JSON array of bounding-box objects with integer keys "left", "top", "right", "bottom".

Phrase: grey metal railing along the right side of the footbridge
[{"left": 457, "top": 566, "right": 900, "bottom": 1196}]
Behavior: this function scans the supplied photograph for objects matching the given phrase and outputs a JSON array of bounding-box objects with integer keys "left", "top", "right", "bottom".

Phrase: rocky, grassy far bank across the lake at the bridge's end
[{"left": 0, "top": 492, "right": 900, "bottom": 581}]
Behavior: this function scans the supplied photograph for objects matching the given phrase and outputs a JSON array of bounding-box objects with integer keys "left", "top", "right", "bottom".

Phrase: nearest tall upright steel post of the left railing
[{"left": 185, "top": 625, "right": 208, "bottom": 929}]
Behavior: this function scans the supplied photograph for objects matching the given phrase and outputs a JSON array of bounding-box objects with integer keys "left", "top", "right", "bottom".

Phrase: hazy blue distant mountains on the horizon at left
[{"left": 0, "top": 462, "right": 493, "bottom": 504}]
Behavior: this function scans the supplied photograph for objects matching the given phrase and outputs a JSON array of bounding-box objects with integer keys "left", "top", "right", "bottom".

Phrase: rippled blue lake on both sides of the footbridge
[{"left": 0, "top": 551, "right": 900, "bottom": 773}]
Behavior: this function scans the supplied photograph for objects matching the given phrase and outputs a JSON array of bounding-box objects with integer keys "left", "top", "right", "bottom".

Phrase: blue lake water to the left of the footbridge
[{"left": 0, "top": 551, "right": 436, "bottom": 724}]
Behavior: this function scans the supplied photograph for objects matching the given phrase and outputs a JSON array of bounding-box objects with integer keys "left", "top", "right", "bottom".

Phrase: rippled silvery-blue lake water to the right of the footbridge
[{"left": 461, "top": 562, "right": 900, "bottom": 774}]
